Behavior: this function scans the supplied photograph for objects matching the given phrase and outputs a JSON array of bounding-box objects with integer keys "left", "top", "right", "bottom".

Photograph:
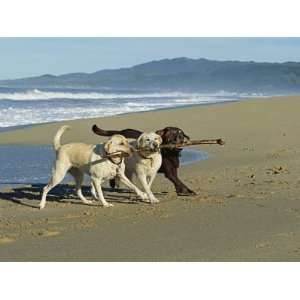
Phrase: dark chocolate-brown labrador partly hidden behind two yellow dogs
[{"left": 92, "top": 125, "right": 195, "bottom": 196}]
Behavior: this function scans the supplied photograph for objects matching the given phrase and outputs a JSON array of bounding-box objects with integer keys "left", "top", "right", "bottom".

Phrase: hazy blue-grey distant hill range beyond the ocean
[{"left": 0, "top": 58, "right": 300, "bottom": 93}]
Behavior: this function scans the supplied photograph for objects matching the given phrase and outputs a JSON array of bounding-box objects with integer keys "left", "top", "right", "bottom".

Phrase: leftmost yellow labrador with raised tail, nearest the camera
[{"left": 40, "top": 126, "right": 148, "bottom": 209}]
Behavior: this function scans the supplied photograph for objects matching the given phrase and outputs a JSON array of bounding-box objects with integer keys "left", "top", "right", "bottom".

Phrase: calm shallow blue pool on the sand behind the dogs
[{"left": 0, "top": 146, "right": 208, "bottom": 189}]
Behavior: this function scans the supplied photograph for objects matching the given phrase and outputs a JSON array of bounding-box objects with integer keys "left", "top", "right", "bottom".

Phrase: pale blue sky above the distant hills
[{"left": 0, "top": 38, "right": 300, "bottom": 79}]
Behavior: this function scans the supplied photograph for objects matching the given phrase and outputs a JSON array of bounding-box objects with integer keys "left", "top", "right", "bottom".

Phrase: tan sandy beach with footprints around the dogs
[{"left": 0, "top": 96, "right": 300, "bottom": 261}]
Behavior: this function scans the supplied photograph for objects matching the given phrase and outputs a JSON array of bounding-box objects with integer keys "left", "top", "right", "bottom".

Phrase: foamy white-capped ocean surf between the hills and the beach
[{"left": 0, "top": 87, "right": 261, "bottom": 130}]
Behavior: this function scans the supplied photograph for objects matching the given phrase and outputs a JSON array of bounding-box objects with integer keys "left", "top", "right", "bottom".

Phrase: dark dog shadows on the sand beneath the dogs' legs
[{"left": 0, "top": 183, "right": 166, "bottom": 208}]
